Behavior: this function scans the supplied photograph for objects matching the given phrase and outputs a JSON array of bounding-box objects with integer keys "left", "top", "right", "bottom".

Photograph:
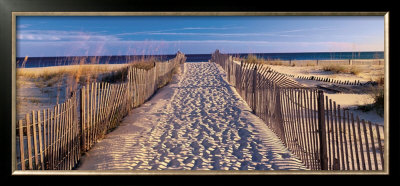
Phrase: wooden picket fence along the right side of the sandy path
[{"left": 211, "top": 51, "right": 384, "bottom": 170}]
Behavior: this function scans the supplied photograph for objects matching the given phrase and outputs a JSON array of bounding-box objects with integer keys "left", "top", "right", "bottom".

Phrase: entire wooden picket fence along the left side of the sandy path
[{"left": 16, "top": 52, "right": 186, "bottom": 170}]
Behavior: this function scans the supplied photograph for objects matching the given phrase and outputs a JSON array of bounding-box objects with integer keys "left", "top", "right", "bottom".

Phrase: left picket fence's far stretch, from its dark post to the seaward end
[{"left": 81, "top": 56, "right": 186, "bottom": 151}]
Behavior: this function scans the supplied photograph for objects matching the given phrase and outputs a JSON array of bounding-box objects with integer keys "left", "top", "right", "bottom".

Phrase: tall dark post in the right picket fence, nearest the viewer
[{"left": 318, "top": 90, "right": 328, "bottom": 170}]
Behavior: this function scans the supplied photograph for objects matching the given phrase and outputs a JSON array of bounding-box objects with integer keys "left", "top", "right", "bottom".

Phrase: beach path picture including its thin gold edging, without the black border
[{"left": 0, "top": 0, "right": 391, "bottom": 175}]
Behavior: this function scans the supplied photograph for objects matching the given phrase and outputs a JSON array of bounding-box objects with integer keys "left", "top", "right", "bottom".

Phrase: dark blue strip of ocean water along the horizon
[{"left": 16, "top": 52, "right": 384, "bottom": 68}]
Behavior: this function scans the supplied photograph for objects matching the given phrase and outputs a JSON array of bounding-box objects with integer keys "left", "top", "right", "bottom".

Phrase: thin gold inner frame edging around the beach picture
[{"left": 11, "top": 11, "right": 390, "bottom": 175}]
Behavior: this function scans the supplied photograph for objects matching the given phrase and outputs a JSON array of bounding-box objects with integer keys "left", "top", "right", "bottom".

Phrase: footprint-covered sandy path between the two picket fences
[{"left": 79, "top": 63, "right": 305, "bottom": 170}]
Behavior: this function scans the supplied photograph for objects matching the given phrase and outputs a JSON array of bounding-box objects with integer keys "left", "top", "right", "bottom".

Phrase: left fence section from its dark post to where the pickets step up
[{"left": 80, "top": 82, "right": 130, "bottom": 151}]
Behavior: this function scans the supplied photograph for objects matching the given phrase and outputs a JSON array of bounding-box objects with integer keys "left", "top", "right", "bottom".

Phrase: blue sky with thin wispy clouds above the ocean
[{"left": 17, "top": 16, "right": 384, "bottom": 57}]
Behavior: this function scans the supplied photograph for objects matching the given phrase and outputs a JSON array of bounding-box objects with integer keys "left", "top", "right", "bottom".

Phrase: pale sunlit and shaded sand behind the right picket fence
[{"left": 269, "top": 65, "right": 384, "bottom": 125}]
